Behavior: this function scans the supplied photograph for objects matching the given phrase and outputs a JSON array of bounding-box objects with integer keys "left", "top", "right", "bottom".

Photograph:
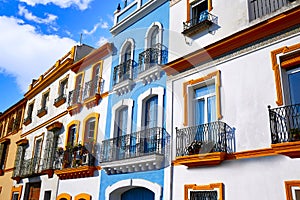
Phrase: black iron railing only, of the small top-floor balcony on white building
[{"left": 183, "top": 11, "right": 217, "bottom": 34}]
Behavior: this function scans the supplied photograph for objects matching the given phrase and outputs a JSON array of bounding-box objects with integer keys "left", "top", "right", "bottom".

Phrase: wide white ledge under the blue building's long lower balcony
[{"left": 101, "top": 154, "right": 164, "bottom": 174}]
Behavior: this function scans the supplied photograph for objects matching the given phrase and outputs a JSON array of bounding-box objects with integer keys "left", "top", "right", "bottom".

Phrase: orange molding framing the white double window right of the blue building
[{"left": 183, "top": 70, "right": 222, "bottom": 126}]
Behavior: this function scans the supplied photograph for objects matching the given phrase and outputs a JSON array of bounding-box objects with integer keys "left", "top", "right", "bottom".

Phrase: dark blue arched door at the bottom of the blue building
[{"left": 121, "top": 187, "right": 154, "bottom": 200}]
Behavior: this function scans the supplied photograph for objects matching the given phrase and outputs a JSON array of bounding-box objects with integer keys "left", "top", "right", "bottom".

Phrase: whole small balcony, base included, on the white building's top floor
[{"left": 182, "top": 11, "right": 217, "bottom": 36}]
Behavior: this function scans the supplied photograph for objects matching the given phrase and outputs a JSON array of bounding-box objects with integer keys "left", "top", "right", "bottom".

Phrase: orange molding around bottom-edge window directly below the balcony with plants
[{"left": 184, "top": 183, "right": 224, "bottom": 200}]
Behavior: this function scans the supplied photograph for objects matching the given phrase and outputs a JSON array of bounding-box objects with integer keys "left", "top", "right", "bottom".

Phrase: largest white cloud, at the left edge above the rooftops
[{"left": 0, "top": 16, "right": 75, "bottom": 92}]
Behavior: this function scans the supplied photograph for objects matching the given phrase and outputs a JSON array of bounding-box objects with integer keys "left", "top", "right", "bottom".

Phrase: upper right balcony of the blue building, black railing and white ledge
[{"left": 138, "top": 44, "right": 168, "bottom": 84}]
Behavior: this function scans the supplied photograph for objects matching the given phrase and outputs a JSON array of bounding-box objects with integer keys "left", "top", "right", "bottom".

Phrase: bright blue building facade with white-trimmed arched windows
[{"left": 99, "top": 0, "right": 170, "bottom": 200}]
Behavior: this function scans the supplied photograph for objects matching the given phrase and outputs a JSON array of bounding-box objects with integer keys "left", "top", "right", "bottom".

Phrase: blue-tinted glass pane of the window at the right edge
[{"left": 288, "top": 71, "right": 300, "bottom": 104}]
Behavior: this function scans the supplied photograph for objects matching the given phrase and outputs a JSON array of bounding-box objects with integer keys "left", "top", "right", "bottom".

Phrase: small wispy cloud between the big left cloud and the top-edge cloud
[{"left": 18, "top": 5, "right": 57, "bottom": 24}]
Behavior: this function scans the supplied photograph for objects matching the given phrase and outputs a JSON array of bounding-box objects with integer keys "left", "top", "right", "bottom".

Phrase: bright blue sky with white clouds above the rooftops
[{"left": 0, "top": 0, "right": 130, "bottom": 112}]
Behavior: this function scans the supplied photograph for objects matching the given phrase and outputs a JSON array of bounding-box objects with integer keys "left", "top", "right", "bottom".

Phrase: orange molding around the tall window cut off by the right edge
[{"left": 271, "top": 43, "right": 300, "bottom": 106}]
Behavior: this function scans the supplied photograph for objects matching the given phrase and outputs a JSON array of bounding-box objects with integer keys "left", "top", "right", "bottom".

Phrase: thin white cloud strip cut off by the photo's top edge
[{"left": 19, "top": 0, "right": 93, "bottom": 10}]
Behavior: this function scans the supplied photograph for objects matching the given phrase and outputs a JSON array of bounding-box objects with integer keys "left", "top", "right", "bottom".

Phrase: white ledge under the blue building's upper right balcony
[{"left": 138, "top": 64, "right": 162, "bottom": 85}]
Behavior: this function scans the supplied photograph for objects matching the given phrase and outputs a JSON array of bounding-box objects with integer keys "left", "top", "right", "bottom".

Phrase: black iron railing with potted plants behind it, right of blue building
[{"left": 176, "top": 121, "right": 234, "bottom": 157}]
